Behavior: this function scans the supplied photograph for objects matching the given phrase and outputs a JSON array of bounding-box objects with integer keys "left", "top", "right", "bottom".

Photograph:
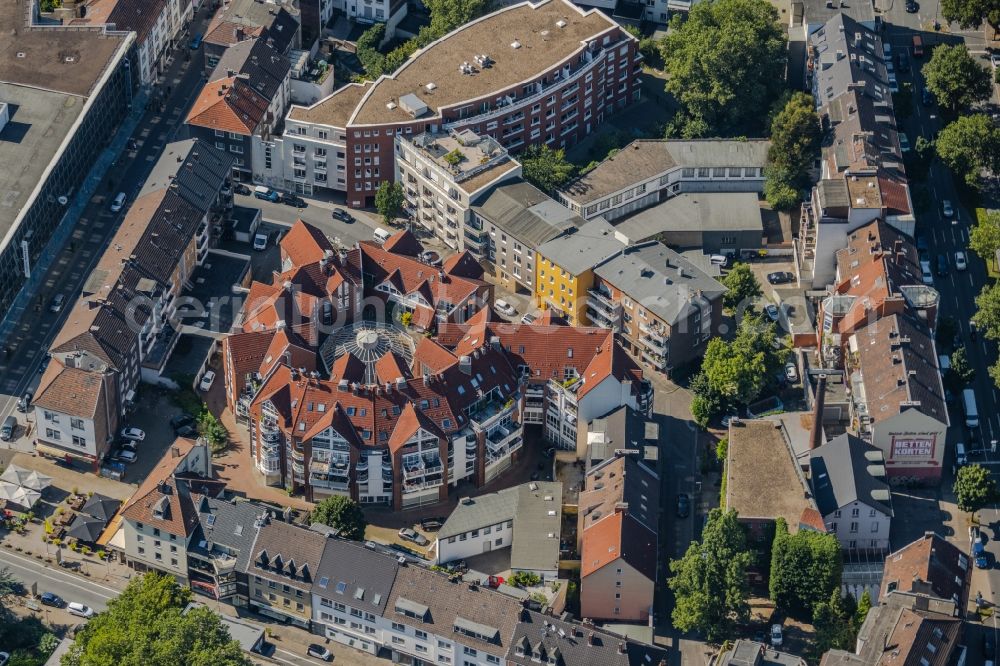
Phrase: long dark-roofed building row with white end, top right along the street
[{"left": 796, "top": 13, "right": 915, "bottom": 288}]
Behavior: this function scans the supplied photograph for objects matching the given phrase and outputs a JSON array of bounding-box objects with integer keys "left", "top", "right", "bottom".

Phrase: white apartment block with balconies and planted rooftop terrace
[{"left": 396, "top": 129, "right": 521, "bottom": 255}]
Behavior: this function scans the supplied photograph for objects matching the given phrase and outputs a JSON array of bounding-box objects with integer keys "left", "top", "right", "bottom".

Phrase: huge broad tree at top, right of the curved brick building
[{"left": 660, "top": 0, "right": 786, "bottom": 138}]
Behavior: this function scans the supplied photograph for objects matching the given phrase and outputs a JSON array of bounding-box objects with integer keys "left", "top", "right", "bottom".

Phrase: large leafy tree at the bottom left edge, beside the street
[{"left": 62, "top": 573, "right": 252, "bottom": 666}]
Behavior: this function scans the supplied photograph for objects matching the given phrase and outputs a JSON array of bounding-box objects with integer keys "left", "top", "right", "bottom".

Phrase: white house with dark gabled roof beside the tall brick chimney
[{"left": 809, "top": 433, "right": 892, "bottom": 554}]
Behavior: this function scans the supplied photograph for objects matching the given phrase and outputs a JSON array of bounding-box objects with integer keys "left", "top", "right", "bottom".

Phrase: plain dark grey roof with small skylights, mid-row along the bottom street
[{"left": 312, "top": 539, "right": 399, "bottom": 615}]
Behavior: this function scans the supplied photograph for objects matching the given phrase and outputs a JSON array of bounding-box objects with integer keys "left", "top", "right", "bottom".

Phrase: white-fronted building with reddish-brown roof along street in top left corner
[{"left": 75, "top": 0, "right": 193, "bottom": 86}]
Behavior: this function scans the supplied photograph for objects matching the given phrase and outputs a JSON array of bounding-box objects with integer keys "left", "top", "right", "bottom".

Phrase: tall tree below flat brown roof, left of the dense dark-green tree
[{"left": 669, "top": 509, "right": 753, "bottom": 641}]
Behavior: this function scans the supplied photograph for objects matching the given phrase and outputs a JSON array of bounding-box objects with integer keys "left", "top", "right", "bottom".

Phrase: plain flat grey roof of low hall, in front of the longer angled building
[{"left": 615, "top": 192, "right": 764, "bottom": 243}]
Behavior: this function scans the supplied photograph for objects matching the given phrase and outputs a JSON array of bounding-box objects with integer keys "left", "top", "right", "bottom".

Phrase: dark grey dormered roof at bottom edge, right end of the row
[{"left": 507, "top": 610, "right": 667, "bottom": 666}]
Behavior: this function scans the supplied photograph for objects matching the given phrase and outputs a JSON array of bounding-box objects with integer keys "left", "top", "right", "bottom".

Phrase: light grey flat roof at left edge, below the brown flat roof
[{"left": 0, "top": 83, "right": 87, "bottom": 246}]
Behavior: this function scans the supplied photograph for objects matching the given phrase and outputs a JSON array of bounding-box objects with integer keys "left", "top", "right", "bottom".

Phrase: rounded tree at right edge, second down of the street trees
[{"left": 935, "top": 113, "right": 1000, "bottom": 189}]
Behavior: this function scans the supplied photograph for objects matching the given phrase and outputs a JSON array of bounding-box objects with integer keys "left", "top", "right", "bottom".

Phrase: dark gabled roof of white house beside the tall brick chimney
[{"left": 809, "top": 433, "right": 892, "bottom": 516}]
